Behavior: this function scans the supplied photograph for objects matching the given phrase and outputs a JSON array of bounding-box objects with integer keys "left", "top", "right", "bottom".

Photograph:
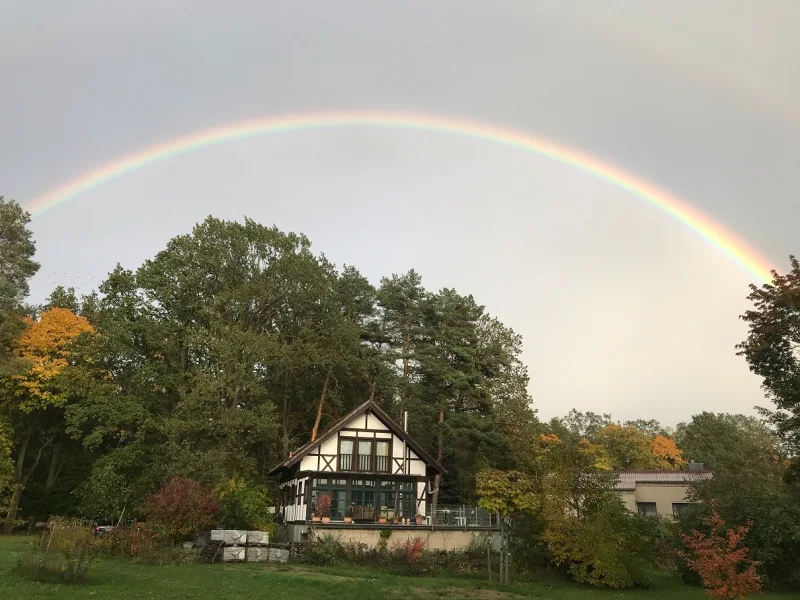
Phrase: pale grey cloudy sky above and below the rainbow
[{"left": 0, "top": 0, "right": 800, "bottom": 425}]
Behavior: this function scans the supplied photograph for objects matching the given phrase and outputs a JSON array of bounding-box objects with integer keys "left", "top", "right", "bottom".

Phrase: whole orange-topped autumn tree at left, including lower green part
[{"left": 3, "top": 308, "right": 97, "bottom": 533}]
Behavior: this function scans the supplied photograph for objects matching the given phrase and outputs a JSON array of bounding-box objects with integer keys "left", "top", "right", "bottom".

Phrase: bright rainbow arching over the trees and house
[{"left": 26, "top": 111, "right": 772, "bottom": 283}]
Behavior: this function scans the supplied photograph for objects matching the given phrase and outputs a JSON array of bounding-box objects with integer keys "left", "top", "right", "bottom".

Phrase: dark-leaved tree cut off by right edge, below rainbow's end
[{"left": 737, "top": 256, "right": 800, "bottom": 448}]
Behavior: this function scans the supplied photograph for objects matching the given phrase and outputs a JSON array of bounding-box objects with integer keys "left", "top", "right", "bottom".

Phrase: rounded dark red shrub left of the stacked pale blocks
[{"left": 145, "top": 477, "right": 219, "bottom": 541}]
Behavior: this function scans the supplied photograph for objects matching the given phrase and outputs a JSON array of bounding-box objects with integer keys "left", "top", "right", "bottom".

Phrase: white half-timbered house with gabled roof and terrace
[{"left": 269, "top": 400, "right": 499, "bottom": 549}]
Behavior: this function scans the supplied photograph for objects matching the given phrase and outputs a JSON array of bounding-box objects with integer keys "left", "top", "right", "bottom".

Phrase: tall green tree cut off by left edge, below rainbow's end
[{"left": 0, "top": 196, "right": 39, "bottom": 367}]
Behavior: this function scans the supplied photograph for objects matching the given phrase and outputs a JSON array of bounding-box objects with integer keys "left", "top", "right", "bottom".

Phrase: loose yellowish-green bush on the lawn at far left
[{"left": 17, "top": 519, "right": 97, "bottom": 584}]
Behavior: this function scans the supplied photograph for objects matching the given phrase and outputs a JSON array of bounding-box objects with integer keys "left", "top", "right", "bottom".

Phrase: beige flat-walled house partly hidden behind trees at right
[{"left": 615, "top": 463, "right": 713, "bottom": 516}]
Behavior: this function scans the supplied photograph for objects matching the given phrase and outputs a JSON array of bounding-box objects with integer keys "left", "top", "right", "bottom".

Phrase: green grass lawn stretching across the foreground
[{"left": 0, "top": 537, "right": 800, "bottom": 600}]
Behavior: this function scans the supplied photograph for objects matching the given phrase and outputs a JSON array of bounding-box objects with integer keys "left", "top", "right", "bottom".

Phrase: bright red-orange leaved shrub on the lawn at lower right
[{"left": 679, "top": 500, "right": 761, "bottom": 600}]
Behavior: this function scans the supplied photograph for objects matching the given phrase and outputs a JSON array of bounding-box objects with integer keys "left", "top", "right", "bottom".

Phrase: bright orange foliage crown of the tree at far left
[{"left": 15, "top": 308, "right": 95, "bottom": 404}]
